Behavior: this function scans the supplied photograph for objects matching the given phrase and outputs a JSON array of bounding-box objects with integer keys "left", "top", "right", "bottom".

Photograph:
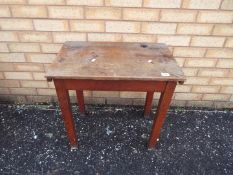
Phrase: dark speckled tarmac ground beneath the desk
[{"left": 0, "top": 104, "right": 233, "bottom": 175}]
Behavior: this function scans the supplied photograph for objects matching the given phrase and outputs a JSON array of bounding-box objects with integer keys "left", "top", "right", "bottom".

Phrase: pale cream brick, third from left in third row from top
[{"left": 70, "top": 20, "right": 104, "bottom": 32}]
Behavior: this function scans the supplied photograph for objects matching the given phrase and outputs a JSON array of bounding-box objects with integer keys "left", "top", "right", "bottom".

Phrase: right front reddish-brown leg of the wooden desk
[{"left": 148, "top": 82, "right": 176, "bottom": 149}]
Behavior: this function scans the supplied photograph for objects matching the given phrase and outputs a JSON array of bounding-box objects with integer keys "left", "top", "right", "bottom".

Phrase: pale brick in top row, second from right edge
[{"left": 183, "top": 0, "right": 221, "bottom": 9}]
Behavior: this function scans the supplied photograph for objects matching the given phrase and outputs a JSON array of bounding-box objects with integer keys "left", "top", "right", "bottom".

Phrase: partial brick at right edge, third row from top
[{"left": 213, "top": 24, "right": 233, "bottom": 36}]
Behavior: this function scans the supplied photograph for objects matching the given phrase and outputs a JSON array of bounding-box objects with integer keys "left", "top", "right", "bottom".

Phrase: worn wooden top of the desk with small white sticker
[{"left": 45, "top": 42, "right": 185, "bottom": 82}]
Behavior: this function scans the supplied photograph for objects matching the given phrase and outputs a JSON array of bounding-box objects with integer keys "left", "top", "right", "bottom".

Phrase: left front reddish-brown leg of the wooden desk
[{"left": 54, "top": 80, "right": 78, "bottom": 149}]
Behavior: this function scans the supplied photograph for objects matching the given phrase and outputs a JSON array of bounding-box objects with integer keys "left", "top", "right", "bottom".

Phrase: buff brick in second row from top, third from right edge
[{"left": 123, "top": 8, "right": 159, "bottom": 21}]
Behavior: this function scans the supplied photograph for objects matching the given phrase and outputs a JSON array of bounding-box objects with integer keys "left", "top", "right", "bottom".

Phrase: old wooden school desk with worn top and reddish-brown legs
[{"left": 46, "top": 42, "right": 185, "bottom": 148}]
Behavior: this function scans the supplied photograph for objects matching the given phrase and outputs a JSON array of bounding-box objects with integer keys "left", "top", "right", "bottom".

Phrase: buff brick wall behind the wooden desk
[{"left": 0, "top": 0, "right": 233, "bottom": 107}]
